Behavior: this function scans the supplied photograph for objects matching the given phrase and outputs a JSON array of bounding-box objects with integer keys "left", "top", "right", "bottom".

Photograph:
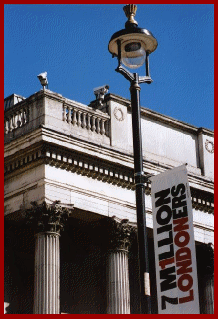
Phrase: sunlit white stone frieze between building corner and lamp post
[{"left": 45, "top": 165, "right": 135, "bottom": 222}]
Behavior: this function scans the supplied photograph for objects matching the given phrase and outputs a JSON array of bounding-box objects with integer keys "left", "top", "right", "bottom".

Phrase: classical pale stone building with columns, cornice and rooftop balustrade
[{"left": 4, "top": 89, "right": 214, "bottom": 314}]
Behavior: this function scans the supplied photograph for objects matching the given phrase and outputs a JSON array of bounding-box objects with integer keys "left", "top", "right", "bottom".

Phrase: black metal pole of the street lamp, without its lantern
[{"left": 130, "top": 73, "right": 151, "bottom": 314}]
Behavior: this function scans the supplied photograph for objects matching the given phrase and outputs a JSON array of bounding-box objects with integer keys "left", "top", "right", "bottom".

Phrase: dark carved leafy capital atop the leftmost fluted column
[{"left": 26, "top": 201, "right": 71, "bottom": 233}]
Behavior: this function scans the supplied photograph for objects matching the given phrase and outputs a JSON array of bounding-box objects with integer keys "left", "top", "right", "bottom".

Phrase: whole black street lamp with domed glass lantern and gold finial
[{"left": 108, "top": 4, "right": 157, "bottom": 314}]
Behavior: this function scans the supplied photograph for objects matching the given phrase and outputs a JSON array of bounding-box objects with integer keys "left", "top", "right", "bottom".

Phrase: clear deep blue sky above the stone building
[{"left": 4, "top": 4, "right": 214, "bottom": 129}]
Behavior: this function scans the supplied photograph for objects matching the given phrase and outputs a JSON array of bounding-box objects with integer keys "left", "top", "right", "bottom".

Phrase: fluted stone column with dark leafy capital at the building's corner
[{"left": 28, "top": 202, "right": 72, "bottom": 314}]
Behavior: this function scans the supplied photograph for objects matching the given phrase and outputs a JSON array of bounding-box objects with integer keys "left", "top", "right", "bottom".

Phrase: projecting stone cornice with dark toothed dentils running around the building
[{"left": 5, "top": 129, "right": 214, "bottom": 213}]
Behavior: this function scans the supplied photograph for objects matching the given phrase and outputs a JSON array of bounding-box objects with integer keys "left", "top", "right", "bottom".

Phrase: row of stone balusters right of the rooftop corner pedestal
[{"left": 63, "top": 104, "right": 110, "bottom": 136}]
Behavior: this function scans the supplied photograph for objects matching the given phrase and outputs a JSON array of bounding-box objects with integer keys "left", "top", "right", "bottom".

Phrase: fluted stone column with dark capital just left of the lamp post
[{"left": 104, "top": 218, "right": 131, "bottom": 314}]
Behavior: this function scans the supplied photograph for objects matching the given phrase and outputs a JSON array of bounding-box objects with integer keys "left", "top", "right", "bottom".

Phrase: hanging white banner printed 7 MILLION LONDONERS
[{"left": 150, "top": 165, "right": 200, "bottom": 314}]
